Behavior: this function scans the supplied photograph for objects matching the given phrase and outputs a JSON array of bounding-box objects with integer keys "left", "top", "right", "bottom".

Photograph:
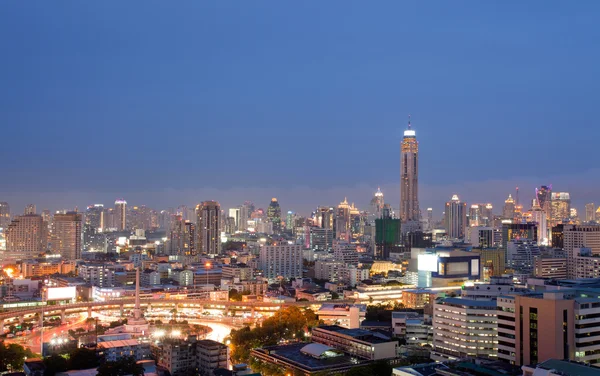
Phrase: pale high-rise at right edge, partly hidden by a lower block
[{"left": 563, "top": 225, "right": 600, "bottom": 278}]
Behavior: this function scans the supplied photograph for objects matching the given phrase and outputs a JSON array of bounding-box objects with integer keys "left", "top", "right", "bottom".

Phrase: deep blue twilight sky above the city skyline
[{"left": 0, "top": 0, "right": 600, "bottom": 215}]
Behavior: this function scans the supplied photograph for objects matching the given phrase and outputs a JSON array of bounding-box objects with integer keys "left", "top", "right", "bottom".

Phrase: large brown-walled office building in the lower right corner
[{"left": 498, "top": 288, "right": 600, "bottom": 366}]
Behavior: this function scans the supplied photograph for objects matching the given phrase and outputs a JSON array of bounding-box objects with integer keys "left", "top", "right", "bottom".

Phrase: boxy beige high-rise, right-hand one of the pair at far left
[{"left": 51, "top": 212, "right": 83, "bottom": 260}]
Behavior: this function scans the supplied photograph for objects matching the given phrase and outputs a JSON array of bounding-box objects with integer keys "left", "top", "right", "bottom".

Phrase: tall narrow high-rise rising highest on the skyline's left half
[{"left": 196, "top": 201, "right": 221, "bottom": 255}]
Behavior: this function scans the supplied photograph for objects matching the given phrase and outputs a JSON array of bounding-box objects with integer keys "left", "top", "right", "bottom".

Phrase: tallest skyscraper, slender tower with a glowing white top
[{"left": 400, "top": 116, "right": 420, "bottom": 223}]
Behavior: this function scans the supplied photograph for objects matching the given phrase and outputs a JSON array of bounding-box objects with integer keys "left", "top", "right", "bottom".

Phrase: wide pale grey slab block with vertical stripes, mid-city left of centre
[{"left": 259, "top": 244, "right": 303, "bottom": 281}]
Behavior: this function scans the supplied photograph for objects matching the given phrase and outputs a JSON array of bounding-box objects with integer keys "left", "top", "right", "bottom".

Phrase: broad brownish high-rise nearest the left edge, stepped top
[{"left": 6, "top": 214, "right": 47, "bottom": 259}]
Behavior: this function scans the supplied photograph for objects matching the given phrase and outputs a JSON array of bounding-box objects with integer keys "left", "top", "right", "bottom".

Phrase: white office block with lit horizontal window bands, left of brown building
[{"left": 431, "top": 298, "right": 498, "bottom": 362}]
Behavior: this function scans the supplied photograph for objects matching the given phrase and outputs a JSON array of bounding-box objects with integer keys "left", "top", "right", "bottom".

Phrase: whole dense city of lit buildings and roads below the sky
[{"left": 0, "top": 119, "right": 600, "bottom": 376}]
